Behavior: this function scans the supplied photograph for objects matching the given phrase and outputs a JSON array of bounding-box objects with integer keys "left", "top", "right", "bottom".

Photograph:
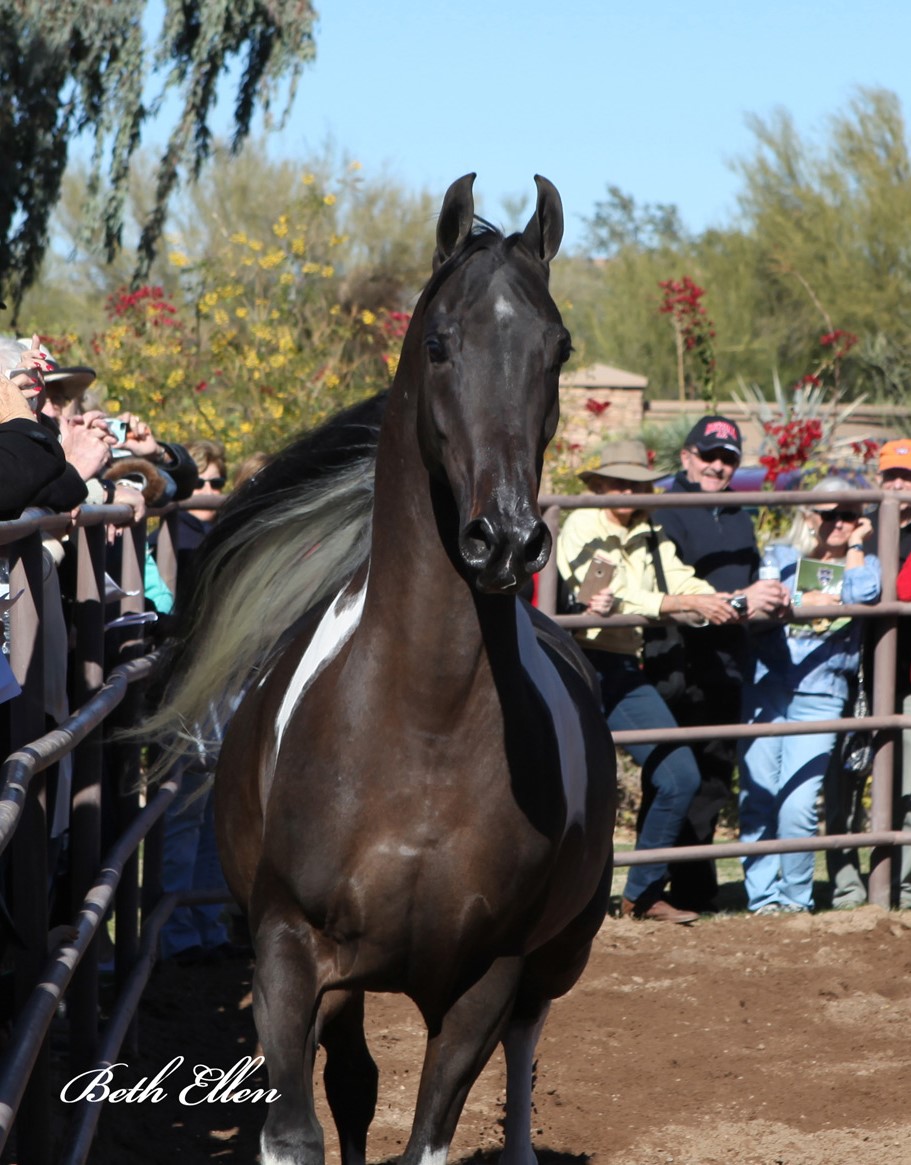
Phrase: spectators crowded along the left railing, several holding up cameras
[{"left": 0, "top": 336, "right": 269, "bottom": 966}]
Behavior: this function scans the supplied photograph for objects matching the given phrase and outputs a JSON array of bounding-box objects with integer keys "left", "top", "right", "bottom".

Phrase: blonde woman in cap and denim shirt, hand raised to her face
[{"left": 740, "top": 476, "right": 882, "bottom": 915}]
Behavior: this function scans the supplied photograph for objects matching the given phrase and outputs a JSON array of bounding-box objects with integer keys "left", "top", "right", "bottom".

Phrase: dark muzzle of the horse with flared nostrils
[{"left": 459, "top": 517, "right": 552, "bottom": 594}]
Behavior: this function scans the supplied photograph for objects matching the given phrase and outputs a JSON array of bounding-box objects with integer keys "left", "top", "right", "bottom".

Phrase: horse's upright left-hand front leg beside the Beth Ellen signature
[{"left": 253, "top": 911, "right": 325, "bottom": 1165}]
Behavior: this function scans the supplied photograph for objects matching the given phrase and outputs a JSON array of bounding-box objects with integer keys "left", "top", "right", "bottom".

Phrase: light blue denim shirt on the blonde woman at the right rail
[{"left": 753, "top": 545, "right": 882, "bottom": 699}]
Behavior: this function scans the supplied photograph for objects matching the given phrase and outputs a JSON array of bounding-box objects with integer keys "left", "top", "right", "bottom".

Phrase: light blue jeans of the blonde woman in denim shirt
[{"left": 740, "top": 677, "right": 845, "bottom": 910}]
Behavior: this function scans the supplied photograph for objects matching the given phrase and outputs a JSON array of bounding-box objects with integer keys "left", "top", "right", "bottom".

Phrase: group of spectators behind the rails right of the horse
[{"left": 557, "top": 416, "right": 911, "bottom": 924}]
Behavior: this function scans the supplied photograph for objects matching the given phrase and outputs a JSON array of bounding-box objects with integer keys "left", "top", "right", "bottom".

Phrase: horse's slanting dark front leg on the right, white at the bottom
[{"left": 401, "top": 958, "right": 523, "bottom": 1165}]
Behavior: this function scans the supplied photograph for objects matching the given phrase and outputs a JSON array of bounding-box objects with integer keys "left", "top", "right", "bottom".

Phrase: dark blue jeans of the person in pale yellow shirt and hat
[{"left": 586, "top": 651, "right": 700, "bottom": 903}]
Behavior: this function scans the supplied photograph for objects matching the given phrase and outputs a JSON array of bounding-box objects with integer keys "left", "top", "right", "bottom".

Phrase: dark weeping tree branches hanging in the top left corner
[{"left": 0, "top": 0, "right": 315, "bottom": 309}]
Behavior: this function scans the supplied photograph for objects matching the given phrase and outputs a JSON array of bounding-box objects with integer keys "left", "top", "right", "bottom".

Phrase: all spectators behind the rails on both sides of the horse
[{"left": 0, "top": 336, "right": 911, "bottom": 963}]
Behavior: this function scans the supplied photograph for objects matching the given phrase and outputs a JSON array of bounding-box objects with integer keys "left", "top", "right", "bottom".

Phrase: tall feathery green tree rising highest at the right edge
[{"left": 736, "top": 89, "right": 911, "bottom": 393}]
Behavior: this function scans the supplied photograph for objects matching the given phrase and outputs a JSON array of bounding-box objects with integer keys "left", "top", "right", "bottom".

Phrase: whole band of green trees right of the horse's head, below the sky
[{"left": 555, "top": 89, "right": 911, "bottom": 400}]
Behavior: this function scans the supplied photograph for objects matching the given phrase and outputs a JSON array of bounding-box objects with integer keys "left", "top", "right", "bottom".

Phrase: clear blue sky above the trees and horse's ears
[{"left": 150, "top": 0, "right": 911, "bottom": 245}]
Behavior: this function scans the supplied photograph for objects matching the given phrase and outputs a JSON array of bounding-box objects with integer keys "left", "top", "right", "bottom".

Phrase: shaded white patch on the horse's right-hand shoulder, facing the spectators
[{"left": 516, "top": 602, "right": 588, "bottom": 829}]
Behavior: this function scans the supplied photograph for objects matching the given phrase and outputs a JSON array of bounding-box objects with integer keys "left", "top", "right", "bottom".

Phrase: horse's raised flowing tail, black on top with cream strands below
[{"left": 141, "top": 398, "right": 384, "bottom": 776}]
